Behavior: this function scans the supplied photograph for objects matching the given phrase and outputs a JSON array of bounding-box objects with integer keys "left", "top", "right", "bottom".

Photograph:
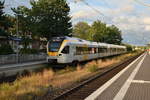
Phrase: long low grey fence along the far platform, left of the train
[{"left": 0, "top": 54, "right": 46, "bottom": 65}]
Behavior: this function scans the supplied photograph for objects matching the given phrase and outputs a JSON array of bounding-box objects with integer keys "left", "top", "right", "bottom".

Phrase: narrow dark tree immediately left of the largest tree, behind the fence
[{"left": 12, "top": 6, "right": 32, "bottom": 50}]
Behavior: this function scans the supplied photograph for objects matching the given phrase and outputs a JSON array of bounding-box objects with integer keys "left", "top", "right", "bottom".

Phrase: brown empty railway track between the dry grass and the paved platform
[{"left": 51, "top": 53, "right": 142, "bottom": 100}]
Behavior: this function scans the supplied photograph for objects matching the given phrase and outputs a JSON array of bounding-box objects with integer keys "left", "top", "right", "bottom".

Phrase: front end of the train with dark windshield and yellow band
[{"left": 47, "top": 37, "right": 65, "bottom": 63}]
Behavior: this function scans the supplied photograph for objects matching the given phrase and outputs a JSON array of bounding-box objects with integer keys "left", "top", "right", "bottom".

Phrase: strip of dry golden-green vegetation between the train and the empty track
[{"left": 0, "top": 52, "right": 142, "bottom": 100}]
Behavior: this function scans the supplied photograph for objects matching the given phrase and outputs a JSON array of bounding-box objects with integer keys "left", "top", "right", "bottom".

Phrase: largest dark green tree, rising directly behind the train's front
[{"left": 31, "top": 0, "right": 72, "bottom": 39}]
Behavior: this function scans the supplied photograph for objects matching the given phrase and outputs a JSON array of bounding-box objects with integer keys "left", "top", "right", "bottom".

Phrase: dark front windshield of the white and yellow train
[{"left": 48, "top": 37, "right": 65, "bottom": 52}]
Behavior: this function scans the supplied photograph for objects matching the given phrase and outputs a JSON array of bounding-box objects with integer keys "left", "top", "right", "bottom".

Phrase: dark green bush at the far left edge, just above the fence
[{"left": 0, "top": 44, "right": 14, "bottom": 55}]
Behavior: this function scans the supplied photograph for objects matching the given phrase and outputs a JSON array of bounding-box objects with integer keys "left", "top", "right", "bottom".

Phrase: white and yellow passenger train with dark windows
[{"left": 47, "top": 36, "right": 127, "bottom": 64}]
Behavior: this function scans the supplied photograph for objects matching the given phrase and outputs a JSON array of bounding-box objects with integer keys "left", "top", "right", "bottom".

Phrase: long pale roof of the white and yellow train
[{"left": 52, "top": 36, "right": 126, "bottom": 48}]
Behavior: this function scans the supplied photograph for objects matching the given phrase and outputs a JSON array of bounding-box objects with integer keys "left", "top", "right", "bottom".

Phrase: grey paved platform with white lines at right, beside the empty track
[{"left": 85, "top": 52, "right": 150, "bottom": 100}]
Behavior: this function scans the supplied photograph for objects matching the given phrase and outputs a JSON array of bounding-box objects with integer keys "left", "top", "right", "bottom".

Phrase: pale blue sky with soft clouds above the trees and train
[{"left": 2, "top": 0, "right": 150, "bottom": 45}]
